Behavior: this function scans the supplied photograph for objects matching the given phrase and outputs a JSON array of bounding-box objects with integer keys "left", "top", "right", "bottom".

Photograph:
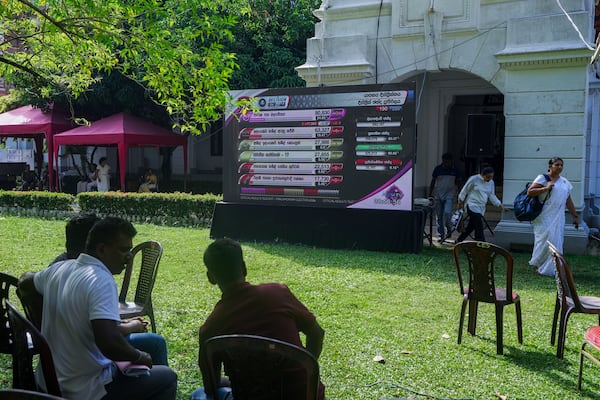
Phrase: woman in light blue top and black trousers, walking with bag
[{"left": 455, "top": 167, "right": 507, "bottom": 243}]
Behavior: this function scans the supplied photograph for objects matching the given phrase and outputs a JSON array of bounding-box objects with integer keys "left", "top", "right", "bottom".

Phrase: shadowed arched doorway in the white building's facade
[{"left": 401, "top": 70, "right": 504, "bottom": 197}]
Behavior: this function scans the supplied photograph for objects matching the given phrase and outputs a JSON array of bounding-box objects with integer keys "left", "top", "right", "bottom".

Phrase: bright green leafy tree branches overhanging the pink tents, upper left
[{"left": 0, "top": 0, "right": 236, "bottom": 134}]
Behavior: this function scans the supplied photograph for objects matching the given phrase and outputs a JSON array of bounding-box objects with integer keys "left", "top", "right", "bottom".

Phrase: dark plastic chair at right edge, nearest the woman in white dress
[{"left": 548, "top": 242, "right": 600, "bottom": 358}]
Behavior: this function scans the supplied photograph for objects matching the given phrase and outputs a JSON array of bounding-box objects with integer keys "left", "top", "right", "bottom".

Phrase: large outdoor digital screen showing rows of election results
[{"left": 223, "top": 84, "right": 416, "bottom": 210}]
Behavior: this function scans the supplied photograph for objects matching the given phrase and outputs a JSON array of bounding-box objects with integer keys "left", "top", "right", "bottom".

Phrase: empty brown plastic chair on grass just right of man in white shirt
[{"left": 119, "top": 240, "right": 162, "bottom": 333}]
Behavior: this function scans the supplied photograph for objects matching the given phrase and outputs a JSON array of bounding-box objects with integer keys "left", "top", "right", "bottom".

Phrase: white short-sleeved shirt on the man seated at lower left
[{"left": 33, "top": 253, "right": 120, "bottom": 400}]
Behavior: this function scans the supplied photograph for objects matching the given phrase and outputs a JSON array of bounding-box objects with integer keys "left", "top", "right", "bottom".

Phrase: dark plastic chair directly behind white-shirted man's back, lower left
[{"left": 5, "top": 300, "right": 61, "bottom": 396}]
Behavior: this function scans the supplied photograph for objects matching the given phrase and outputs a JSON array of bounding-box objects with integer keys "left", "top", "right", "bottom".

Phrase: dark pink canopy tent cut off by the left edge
[{"left": 0, "top": 105, "right": 73, "bottom": 190}]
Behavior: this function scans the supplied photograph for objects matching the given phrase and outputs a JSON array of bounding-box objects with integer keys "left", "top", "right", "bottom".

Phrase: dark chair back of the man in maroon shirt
[{"left": 200, "top": 335, "right": 319, "bottom": 400}]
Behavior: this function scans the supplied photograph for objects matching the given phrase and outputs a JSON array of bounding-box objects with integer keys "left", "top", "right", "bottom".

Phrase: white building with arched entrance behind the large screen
[{"left": 297, "top": 0, "right": 600, "bottom": 253}]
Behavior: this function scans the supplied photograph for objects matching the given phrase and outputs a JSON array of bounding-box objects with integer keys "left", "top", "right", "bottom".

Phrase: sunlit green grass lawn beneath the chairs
[{"left": 0, "top": 215, "right": 600, "bottom": 400}]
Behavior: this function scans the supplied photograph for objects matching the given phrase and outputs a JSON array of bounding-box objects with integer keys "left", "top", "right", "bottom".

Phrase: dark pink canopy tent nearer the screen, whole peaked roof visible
[{"left": 53, "top": 113, "right": 187, "bottom": 192}]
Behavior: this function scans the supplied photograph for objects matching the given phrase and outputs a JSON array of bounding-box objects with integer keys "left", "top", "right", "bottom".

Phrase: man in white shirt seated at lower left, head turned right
[{"left": 18, "top": 217, "right": 177, "bottom": 400}]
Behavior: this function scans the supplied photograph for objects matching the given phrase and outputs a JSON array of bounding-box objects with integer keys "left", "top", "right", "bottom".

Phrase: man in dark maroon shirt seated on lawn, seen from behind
[{"left": 191, "top": 238, "right": 325, "bottom": 400}]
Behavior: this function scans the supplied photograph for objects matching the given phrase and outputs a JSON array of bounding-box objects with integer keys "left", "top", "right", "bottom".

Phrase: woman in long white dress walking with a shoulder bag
[{"left": 527, "top": 157, "right": 579, "bottom": 276}]
